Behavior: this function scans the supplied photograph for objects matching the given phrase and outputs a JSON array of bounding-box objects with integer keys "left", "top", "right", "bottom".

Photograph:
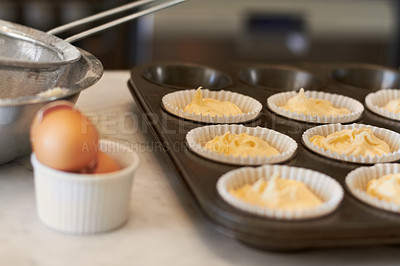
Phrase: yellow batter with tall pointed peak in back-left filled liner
[{"left": 183, "top": 87, "right": 243, "bottom": 116}]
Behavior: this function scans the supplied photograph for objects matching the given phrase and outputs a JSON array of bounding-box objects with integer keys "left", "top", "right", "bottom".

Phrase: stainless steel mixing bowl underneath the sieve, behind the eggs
[{"left": 0, "top": 50, "right": 103, "bottom": 164}]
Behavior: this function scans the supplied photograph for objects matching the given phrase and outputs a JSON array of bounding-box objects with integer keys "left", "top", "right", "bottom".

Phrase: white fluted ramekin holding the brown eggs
[{"left": 31, "top": 140, "right": 139, "bottom": 234}]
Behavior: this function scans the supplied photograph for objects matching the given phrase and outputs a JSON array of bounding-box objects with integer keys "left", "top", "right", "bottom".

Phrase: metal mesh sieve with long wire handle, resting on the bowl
[{"left": 0, "top": 0, "right": 185, "bottom": 70}]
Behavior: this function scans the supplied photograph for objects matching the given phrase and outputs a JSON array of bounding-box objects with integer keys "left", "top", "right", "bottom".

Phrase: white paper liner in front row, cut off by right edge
[{"left": 346, "top": 164, "right": 400, "bottom": 213}]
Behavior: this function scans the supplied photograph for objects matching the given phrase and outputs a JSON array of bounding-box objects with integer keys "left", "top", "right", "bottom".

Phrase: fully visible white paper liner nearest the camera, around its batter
[{"left": 217, "top": 165, "right": 344, "bottom": 220}]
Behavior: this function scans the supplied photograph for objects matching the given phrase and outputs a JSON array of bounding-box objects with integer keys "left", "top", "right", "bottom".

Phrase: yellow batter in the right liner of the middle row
[{"left": 310, "top": 128, "right": 391, "bottom": 157}]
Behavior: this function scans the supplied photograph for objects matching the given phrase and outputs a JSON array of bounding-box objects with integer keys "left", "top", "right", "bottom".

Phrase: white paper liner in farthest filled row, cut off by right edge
[{"left": 365, "top": 90, "right": 400, "bottom": 121}]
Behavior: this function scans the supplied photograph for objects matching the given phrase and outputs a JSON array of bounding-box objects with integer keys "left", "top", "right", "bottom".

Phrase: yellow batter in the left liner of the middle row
[{"left": 205, "top": 131, "right": 279, "bottom": 157}]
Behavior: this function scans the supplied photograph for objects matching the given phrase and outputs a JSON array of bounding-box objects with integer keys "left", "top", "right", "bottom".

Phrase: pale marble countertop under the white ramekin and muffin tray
[{"left": 0, "top": 71, "right": 400, "bottom": 266}]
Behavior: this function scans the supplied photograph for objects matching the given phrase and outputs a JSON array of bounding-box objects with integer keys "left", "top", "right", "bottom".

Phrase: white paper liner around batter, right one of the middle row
[{"left": 302, "top": 124, "right": 400, "bottom": 164}]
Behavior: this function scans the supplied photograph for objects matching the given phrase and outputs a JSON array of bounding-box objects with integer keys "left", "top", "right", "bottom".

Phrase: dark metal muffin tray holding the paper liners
[{"left": 128, "top": 62, "right": 400, "bottom": 250}]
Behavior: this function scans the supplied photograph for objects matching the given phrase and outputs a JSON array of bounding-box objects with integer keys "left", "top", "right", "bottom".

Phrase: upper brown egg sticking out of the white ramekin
[{"left": 31, "top": 101, "right": 99, "bottom": 172}]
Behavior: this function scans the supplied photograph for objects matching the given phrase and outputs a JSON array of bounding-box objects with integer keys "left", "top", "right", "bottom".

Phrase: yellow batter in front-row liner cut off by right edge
[{"left": 367, "top": 173, "right": 400, "bottom": 204}]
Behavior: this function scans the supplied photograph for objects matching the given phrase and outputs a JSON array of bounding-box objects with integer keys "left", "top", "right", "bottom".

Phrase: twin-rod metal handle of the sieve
[{"left": 47, "top": 0, "right": 186, "bottom": 43}]
